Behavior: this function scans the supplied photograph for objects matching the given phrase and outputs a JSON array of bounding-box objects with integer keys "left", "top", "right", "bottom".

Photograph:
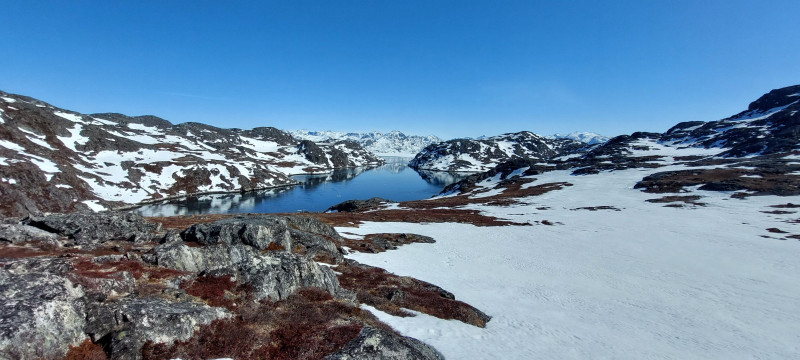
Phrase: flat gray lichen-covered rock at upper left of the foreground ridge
[{"left": 25, "top": 212, "right": 160, "bottom": 245}]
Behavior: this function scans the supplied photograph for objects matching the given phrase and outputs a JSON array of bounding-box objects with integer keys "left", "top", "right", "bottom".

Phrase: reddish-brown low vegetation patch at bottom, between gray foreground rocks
[{"left": 142, "top": 288, "right": 394, "bottom": 360}]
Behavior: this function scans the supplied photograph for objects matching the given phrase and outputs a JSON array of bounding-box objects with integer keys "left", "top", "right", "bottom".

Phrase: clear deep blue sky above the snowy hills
[{"left": 0, "top": 0, "right": 800, "bottom": 138}]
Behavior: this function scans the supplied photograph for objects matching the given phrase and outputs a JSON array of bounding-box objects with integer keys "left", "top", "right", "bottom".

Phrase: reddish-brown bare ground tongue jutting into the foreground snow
[{"left": 333, "top": 261, "right": 491, "bottom": 327}]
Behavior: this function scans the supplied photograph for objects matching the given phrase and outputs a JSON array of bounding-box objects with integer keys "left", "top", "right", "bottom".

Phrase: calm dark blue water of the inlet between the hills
[{"left": 134, "top": 158, "right": 468, "bottom": 216}]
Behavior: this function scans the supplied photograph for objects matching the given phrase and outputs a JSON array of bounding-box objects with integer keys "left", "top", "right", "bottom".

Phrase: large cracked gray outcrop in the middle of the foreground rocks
[{"left": 147, "top": 216, "right": 353, "bottom": 300}]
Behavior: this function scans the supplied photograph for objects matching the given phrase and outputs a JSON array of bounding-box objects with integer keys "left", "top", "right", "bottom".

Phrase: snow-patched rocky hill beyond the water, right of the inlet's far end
[{"left": 409, "top": 131, "right": 587, "bottom": 172}]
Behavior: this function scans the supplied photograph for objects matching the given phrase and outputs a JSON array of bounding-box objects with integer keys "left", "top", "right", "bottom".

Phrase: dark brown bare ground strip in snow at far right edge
[{"left": 634, "top": 168, "right": 800, "bottom": 197}]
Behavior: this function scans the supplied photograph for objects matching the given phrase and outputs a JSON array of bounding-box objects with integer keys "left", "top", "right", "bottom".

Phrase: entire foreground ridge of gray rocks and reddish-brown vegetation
[{"left": 0, "top": 212, "right": 468, "bottom": 359}]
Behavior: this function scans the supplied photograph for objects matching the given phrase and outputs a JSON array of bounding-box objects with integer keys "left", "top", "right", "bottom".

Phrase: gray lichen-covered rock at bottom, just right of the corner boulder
[{"left": 85, "top": 297, "right": 230, "bottom": 360}]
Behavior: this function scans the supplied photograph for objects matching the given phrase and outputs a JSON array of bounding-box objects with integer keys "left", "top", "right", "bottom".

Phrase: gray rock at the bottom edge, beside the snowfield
[{"left": 325, "top": 327, "right": 444, "bottom": 360}]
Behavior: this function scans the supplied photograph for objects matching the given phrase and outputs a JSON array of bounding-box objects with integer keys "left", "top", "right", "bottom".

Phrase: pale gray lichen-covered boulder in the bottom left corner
[{"left": 0, "top": 263, "right": 86, "bottom": 359}]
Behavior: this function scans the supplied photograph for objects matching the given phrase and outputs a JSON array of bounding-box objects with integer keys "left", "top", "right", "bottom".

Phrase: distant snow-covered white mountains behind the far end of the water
[{"left": 289, "top": 130, "right": 442, "bottom": 157}]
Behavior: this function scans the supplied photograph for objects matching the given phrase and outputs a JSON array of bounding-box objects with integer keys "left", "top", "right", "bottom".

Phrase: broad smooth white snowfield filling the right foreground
[{"left": 337, "top": 142, "right": 800, "bottom": 359}]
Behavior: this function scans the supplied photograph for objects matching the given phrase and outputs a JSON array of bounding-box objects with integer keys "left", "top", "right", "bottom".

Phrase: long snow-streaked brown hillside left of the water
[{"left": 0, "top": 91, "right": 383, "bottom": 215}]
